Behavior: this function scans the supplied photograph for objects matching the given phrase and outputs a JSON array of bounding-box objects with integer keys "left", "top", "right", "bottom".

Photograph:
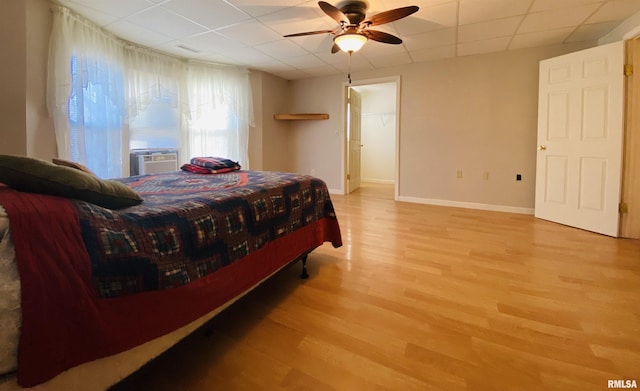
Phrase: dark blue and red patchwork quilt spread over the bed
[{"left": 76, "top": 171, "right": 335, "bottom": 297}]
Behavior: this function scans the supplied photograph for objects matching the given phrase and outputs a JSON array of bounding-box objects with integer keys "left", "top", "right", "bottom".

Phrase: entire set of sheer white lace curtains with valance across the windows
[{"left": 47, "top": 6, "right": 253, "bottom": 178}]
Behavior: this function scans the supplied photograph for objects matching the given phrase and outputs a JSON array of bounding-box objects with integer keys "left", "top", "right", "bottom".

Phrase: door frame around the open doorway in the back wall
[{"left": 342, "top": 76, "right": 401, "bottom": 201}]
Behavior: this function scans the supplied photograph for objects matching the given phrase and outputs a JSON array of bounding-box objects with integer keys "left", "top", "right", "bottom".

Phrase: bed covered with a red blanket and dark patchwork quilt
[{"left": 0, "top": 166, "right": 342, "bottom": 389}]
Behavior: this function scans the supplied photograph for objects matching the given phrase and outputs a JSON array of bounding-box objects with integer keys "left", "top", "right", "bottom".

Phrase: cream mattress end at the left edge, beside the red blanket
[{"left": 0, "top": 205, "right": 21, "bottom": 375}]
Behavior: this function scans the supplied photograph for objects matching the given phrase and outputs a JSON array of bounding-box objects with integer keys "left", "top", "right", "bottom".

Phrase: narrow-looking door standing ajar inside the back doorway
[{"left": 347, "top": 88, "right": 362, "bottom": 193}]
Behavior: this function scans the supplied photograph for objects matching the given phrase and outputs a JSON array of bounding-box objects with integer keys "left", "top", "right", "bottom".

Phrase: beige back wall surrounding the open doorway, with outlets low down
[{"left": 291, "top": 43, "right": 590, "bottom": 211}]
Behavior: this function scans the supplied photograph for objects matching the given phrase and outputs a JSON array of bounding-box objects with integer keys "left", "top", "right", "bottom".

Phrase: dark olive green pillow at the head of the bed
[{"left": 0, "top": 155, "right": 142, "bottom": 209}]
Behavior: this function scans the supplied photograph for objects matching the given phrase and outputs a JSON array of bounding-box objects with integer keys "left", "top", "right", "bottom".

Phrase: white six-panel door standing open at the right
[{"left": 535, "top": 42, "right": 624, "bottom": 236}]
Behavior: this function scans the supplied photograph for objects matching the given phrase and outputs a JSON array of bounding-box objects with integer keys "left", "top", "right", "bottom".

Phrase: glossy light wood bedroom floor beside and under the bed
[{"left": 115, "top": 191, "right": 640, "bottom": 391}]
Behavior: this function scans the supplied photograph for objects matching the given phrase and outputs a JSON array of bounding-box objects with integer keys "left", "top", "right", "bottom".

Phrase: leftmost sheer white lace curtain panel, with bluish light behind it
[{"left": 47, "top": 8, "right": 124, "bottom": 177}]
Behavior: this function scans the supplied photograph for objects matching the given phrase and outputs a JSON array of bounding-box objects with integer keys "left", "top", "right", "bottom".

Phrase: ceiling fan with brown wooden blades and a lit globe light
[{"left": 285, "top": 0, "right": 419, "bottom": 53}]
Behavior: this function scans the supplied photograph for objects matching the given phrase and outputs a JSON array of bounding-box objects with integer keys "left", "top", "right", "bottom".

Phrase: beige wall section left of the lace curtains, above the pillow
[{"left": 0, "top": 0, "right": 56, "bottom": 159}]
